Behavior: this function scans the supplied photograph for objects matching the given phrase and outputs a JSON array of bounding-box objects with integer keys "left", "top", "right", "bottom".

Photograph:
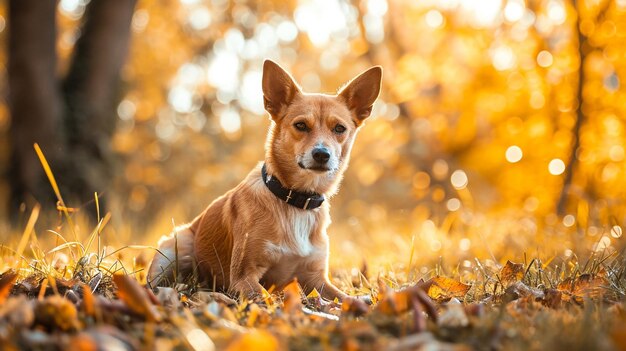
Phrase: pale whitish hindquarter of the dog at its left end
[{"left": 147, "top": 224, "right": 194, "bottom": 287}]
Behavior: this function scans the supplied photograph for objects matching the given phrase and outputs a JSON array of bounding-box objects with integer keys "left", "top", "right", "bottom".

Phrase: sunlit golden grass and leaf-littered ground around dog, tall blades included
[{"left": 0, "top": 147, "right": 626, "bottom": 351}]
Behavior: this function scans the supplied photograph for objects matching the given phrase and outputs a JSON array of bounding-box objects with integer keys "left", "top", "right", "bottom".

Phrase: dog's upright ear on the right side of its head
[{"left": 339, "top": 66, "right": 383, "bottom": 123}]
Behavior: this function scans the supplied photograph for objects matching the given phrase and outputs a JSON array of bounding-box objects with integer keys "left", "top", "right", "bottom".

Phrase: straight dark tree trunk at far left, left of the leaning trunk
[{"left": 7, "top": 0, "right": 64, "bottom": 213}]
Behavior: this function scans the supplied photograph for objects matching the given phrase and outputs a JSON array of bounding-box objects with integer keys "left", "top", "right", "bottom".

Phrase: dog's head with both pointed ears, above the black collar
[{"left": 263, "top": 60, "right": 382, "bottom": 194}]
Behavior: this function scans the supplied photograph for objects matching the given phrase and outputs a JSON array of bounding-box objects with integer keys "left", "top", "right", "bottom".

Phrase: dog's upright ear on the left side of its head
[{"left": 263, "top": 60, "right": 300, "bottom": 120}]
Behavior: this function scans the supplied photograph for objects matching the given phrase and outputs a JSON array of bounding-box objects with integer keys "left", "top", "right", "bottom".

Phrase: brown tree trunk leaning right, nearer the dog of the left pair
[{"left": 63, "top": 0, "right": 136, "bottom": 201}]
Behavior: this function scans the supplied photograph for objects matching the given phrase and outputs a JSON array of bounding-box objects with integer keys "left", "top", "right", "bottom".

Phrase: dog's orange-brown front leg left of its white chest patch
[{"left": 230, "top": 234, "right": 269, "bottom": 300}]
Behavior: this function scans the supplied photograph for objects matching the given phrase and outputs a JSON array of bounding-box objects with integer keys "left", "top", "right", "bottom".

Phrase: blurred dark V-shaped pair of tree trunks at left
[{"left": 8, "top": 0, "right": 136, "bottom": 220}]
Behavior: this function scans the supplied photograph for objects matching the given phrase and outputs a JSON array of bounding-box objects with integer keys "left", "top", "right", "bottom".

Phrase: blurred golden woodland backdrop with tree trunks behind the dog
[{"left": 0, "top": 0, "right": 626, "bottom": 273}]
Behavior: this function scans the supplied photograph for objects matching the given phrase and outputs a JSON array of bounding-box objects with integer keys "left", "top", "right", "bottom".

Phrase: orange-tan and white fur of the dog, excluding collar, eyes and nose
[{"left": 148, "top": 61, "right": 382, "bottom": 300}]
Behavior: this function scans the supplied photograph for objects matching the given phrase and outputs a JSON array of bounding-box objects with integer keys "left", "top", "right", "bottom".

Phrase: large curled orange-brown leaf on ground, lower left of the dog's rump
[{"left": 113, "top": 274, "right": 162, "bottom": 322}]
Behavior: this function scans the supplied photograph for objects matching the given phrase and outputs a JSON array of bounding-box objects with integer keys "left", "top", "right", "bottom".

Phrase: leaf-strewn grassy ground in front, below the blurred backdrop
[{"left": 0, "top": 212, "right": 626, "bottom": 351}]
